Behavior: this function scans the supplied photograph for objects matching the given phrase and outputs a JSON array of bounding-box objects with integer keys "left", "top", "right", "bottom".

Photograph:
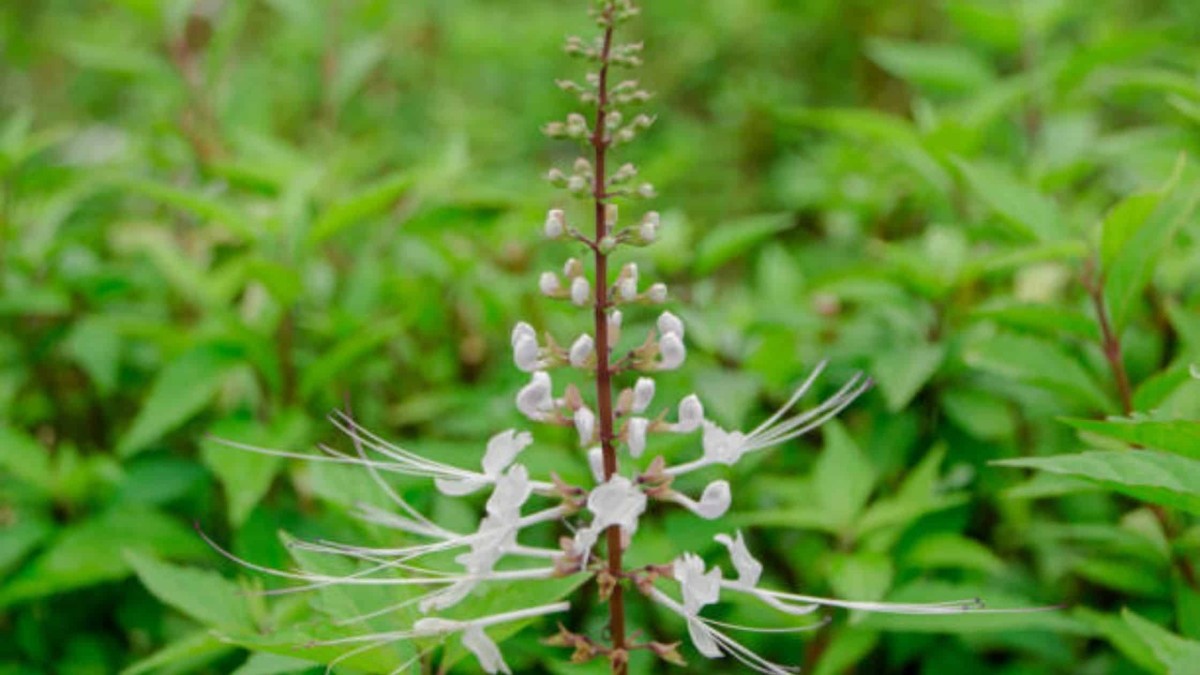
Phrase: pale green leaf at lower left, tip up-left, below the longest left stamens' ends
[{"left": 126, "top": 551, "right": 254, "bottom": 632}]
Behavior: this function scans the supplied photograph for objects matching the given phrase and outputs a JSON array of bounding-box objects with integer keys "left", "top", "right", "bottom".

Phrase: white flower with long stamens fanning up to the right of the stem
[{"left": 666, "top": 362, "right": 871, "bottom": 476}]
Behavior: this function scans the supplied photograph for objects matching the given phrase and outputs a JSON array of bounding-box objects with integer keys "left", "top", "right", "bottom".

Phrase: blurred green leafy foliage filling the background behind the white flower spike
[{"left": 0, "top": 0, "right": 1200, "bottom": 675}]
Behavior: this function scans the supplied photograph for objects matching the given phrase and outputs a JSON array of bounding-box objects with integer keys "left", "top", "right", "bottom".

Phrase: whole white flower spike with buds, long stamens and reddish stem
[{"left": 204, "top": 0, "right": 1022, "bottom": 674}]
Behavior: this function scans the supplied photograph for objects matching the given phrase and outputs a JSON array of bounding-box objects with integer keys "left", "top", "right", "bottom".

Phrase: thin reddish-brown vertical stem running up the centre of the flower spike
[{"left": 592, "top": 6, "right": 628, "bottom": 675}]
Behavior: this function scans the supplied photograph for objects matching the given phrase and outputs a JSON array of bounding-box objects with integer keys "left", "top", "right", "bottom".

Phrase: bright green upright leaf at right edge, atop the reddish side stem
[{"left": 1104, "top": 156, "right": 1200, "bottom": 330}]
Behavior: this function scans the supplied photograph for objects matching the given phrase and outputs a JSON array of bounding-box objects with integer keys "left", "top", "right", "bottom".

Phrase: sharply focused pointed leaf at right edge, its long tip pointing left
[{"left": 992, "top": 450, "right": 1200, "bottom": 514}]
